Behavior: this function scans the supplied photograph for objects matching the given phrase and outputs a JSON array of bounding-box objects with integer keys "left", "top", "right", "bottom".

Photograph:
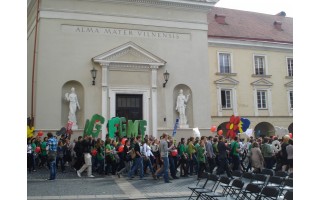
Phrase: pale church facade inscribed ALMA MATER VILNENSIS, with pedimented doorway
[{"left": 28, "top": 0, "right": 216, "bottom": 141}]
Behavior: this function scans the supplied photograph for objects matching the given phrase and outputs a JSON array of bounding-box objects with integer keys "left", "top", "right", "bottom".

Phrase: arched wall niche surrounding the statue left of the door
[{"left": 61, "top": 80, "right": 85, "bottom": 129}]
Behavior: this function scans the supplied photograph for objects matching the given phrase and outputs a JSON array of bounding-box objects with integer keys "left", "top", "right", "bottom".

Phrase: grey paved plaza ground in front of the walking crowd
[{"left": 27, "top": 168, "right": 196, "bottom": 200}]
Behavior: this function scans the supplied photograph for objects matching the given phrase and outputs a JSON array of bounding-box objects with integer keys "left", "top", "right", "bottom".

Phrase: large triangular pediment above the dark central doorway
[{"left": 92, "top": 42, "right": 166, "bottom": 66}]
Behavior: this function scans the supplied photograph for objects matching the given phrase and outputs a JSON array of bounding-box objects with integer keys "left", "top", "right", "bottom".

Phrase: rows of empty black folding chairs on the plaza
[{"left": 189, "top": 171, "right": 293, "bottom": 200}]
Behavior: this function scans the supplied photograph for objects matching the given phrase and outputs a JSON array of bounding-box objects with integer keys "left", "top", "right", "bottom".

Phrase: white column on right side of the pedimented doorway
[{"left": 150, "top": 66, "right": 158, "bottom": 138}]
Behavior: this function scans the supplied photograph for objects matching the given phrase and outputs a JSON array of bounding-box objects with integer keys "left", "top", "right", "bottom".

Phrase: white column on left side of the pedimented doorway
[{"left": 101, "top": 63, "right": 110, "bottom": 140}]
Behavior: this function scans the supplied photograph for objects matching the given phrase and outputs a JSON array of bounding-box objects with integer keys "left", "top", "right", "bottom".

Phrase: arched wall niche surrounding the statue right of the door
[{"left": 172, "top": 84, "right": 194, "bottom": 128}]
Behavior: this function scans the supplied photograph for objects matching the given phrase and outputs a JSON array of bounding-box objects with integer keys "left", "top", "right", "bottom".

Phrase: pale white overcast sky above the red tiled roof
[{"left": 216, "top": 0, "right": 294, "bottom": 17}]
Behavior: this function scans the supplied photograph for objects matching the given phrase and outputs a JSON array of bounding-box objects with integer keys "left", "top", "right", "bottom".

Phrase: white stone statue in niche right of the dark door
[{"left": 176, "top": 89, "right": 190, "bottom": 128}]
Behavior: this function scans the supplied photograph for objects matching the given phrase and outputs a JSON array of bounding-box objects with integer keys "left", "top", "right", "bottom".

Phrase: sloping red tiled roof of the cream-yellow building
[{"left": 208, "top": 7, "right": 293, "bottom": 43}]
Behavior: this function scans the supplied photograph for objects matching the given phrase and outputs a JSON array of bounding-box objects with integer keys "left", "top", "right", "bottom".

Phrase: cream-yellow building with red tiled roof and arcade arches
[{"left": 208, "top": 8, "right": 293, "bottom": 136}]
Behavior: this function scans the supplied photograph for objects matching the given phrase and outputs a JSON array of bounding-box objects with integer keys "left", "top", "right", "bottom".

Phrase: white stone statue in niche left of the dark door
[{"left": 65, "top": 87, "right": 80, "bottom": 130}]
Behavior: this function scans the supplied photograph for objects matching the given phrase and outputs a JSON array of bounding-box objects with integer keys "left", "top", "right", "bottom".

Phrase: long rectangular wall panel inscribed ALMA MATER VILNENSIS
[{"left": 61, "top": 25, "right": 190, "bottom": 40}]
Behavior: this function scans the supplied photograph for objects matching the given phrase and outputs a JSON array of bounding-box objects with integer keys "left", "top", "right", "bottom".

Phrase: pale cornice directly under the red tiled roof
[{"left": 208, "top": 38, "right": 293, "bottom": 51}]
